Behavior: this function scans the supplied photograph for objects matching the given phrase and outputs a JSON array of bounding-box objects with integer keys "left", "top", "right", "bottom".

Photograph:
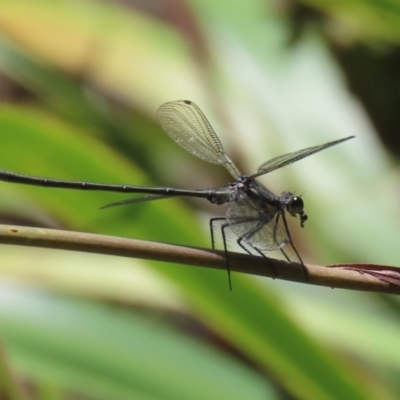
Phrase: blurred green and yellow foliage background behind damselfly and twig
[{"left": 0, "top": 0, "right": 400, "bottom": 400}]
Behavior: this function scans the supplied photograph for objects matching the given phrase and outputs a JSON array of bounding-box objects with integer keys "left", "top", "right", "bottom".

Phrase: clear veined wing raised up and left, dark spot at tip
[{"left": 157, "top": 100, "right": 240, "bottom": 178}]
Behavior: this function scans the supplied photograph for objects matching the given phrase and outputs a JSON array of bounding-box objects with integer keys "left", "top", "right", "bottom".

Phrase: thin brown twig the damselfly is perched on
[{"left": 0, "top": 225, "right": 400, "bottom": 294}]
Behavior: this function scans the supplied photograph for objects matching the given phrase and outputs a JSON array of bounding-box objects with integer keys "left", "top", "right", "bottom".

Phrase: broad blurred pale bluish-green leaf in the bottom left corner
[{"left": 0, "top": 285, "right": 277, "bottom": 400}]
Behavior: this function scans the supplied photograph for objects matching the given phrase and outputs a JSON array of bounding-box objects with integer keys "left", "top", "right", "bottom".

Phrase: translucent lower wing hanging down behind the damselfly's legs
[{"left": 226, "top": 196, "right": 290, "bottom": 252}]
